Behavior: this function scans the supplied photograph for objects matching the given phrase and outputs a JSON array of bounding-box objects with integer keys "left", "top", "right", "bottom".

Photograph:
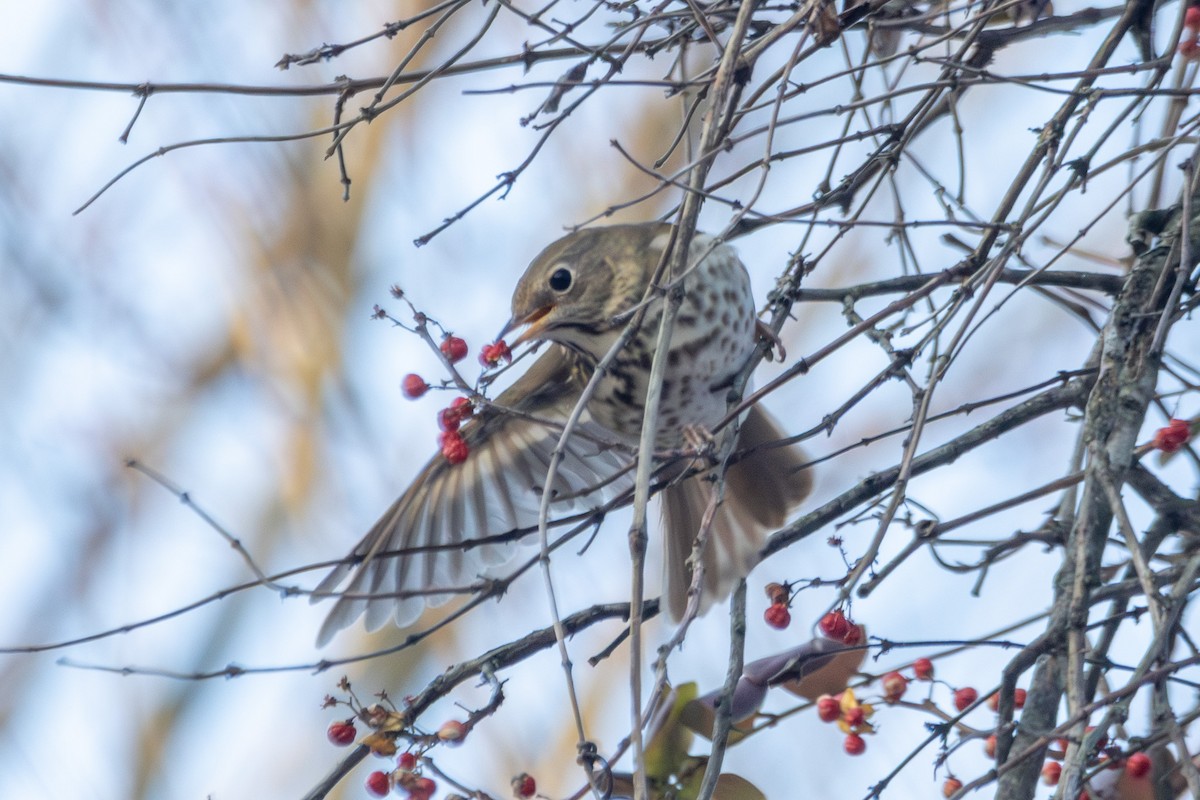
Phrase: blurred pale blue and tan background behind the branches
[{"left": 0, "top": 0, "right": 1198, "bottom": 800}]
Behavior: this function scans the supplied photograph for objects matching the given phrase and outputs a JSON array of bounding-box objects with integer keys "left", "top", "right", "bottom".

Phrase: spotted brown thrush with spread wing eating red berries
[{"left": 314, "top": 223, "right": 810, "bottom": 644}]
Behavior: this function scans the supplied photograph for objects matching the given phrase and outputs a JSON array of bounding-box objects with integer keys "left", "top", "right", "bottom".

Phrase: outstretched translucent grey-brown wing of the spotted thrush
[{"left": 312, "top": 345, "right": 632, "bottom": 645}]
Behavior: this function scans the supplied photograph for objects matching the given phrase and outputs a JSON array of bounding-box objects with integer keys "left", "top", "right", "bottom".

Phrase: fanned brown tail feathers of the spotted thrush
[{"left": 662, "top": 407, "right": 812, "bottom": 620}]
